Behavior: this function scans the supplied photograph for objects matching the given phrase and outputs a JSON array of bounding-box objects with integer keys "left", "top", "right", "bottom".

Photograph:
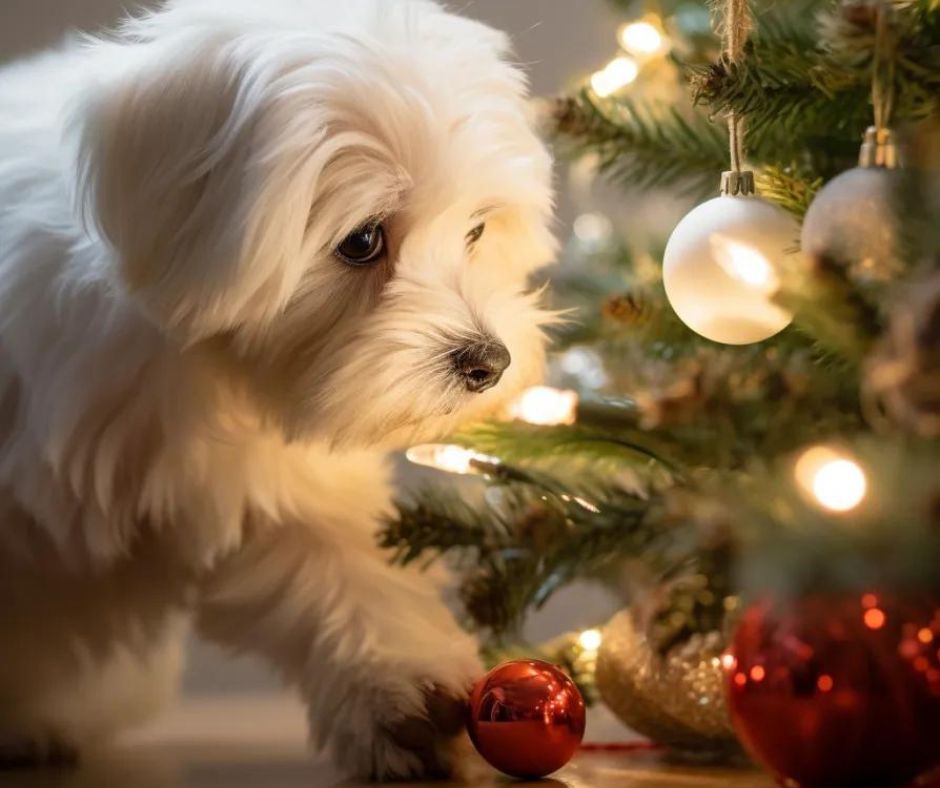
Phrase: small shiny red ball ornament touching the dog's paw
[{"left": 467, "top": 659, "right": 584, "bottom": 779}]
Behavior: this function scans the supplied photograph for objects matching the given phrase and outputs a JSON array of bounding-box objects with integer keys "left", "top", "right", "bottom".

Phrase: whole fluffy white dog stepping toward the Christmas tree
[{"left": 0, "top": 0, "right": 553, "bottom": 778}]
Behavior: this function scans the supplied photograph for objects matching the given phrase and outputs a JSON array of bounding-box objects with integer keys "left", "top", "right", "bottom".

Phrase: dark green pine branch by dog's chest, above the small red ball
[{"left": 380, "top": 480, "right": 661, "bottom": 636}]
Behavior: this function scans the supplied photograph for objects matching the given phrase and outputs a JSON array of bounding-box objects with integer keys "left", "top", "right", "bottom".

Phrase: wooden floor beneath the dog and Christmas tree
[{"left": 0, "top": 697, "right": 773, "bottom": 788}]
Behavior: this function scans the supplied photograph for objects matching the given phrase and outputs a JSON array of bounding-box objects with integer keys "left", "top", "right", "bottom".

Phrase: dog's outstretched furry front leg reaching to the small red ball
[{"left": 199, "top": 452, "right": 480, "bottom": 779}]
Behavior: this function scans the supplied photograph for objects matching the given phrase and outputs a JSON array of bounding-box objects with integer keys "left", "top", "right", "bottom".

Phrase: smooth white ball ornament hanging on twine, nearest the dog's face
[{"left": 663, "top": 172, "right": 800, "bottom": 345}]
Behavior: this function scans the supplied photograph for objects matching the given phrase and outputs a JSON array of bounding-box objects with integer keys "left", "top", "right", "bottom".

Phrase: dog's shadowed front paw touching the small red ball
[{"left": 333, "top": 685, "right": 482, "bottom": 781}]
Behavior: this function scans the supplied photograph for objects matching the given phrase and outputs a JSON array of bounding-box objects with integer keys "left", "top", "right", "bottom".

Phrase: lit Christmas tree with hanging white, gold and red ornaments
[{"left": 382, "top": 0, "right": 940, "bottom": 785}]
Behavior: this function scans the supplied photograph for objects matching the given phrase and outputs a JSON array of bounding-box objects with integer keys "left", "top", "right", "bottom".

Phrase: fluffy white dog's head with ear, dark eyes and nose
[{"left": 80, "top": 0, "right": 553, "bottom": 443}]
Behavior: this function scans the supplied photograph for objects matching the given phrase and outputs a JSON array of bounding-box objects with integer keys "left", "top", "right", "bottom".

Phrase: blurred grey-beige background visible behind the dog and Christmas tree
[{"left": 0, "top": 0, "right": 668, "bottom": 694}]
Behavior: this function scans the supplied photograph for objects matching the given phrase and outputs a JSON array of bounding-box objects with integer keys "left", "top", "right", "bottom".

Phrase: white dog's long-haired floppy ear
[{"left": 77, "top": 41, "right": 316, "bottom": 341}]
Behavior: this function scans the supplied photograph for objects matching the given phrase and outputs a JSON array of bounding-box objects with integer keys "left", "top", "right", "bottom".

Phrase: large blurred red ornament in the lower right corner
[{"left": 724, "top": 592, "right": 940, "bottom": 788}]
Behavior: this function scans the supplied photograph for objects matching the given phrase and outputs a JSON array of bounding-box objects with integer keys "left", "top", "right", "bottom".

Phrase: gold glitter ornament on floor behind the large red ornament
[{"left": 595, "top": 609, "right": 739, "bottom": 755}]
